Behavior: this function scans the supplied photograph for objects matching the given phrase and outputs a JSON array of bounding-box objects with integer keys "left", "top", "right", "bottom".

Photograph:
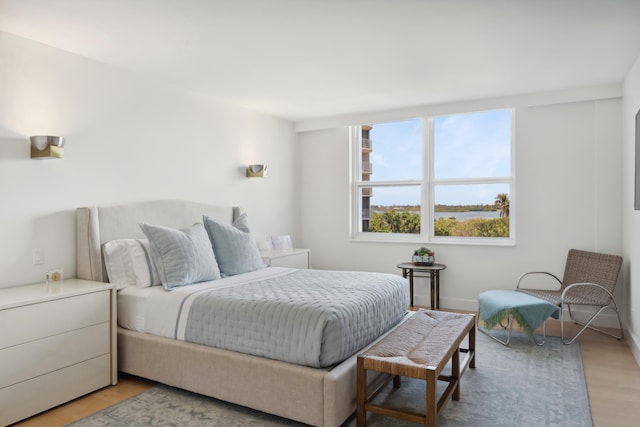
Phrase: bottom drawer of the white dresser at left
[{"left": 0, "top": 355, "right": 111, "bottom": 425}]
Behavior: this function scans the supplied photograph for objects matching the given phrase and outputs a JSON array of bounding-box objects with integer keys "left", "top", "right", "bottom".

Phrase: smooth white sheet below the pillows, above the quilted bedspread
[{"left": 118, "top": 267, "right": 295, "bottom": 340}]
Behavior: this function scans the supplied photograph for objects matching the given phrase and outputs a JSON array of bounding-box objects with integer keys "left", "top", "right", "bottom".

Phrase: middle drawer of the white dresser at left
[{"left": 0, "top": 322, "right": 111, "bottom": 388}]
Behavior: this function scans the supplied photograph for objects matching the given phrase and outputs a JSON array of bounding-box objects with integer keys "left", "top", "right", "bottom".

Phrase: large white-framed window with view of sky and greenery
[{"left": 352, "top": 110, "right": 514, "bottom": 244}]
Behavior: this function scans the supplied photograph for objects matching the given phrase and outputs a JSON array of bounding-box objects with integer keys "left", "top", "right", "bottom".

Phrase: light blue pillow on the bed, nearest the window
[{"left": 203, "top": 213, "right": 266, "bottom": 276}]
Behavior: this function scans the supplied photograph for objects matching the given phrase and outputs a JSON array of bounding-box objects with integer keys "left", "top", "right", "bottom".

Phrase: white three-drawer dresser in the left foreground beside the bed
[{"left": 0, "top": 279, "right": 118, "bottom": 425}]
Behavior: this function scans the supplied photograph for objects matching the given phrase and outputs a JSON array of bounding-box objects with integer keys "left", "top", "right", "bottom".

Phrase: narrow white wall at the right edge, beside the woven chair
[{"left": 622, "top": 57, "right": 640, "bottom": 363}]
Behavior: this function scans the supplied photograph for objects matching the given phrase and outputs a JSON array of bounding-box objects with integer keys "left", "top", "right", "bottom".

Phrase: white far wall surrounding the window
[{"left": 299, "top": 86, "right": 622, "bottom": 320}]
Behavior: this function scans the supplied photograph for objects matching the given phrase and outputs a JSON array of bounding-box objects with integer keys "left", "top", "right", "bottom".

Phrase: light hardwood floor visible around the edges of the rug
[{"left": 14, "top": 319, "right": 640, "bottom": 427}]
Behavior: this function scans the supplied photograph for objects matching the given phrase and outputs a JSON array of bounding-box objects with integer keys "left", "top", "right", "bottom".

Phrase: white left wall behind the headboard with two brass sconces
[{"left": 0, "top": 32, "right": 299, "bottom": 287}]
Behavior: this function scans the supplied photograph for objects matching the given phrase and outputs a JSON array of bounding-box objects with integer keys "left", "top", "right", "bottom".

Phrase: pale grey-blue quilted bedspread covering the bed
[{"left": 184, "top": 270, "right": 409, "bottom": 368}]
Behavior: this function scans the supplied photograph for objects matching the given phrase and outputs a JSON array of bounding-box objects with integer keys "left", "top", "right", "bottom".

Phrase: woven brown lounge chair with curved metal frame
[{"left": 516, "top": 249, "right": 624, "bottom": 344}]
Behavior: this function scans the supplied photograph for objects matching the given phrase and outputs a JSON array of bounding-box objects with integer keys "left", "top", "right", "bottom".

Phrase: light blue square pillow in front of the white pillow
[{"left": 140, "top": 224, "right": 220, "bottom": 290}]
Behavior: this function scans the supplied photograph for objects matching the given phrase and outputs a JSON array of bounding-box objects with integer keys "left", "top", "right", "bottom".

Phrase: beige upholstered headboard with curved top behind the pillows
[{"left": 76, "top": 200, "right": 243, "bottom": 282}]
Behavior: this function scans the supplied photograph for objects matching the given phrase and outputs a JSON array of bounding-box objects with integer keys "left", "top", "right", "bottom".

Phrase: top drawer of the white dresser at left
[{"left": 0, "top": 290, "right": 111, "bottom": 349}]
